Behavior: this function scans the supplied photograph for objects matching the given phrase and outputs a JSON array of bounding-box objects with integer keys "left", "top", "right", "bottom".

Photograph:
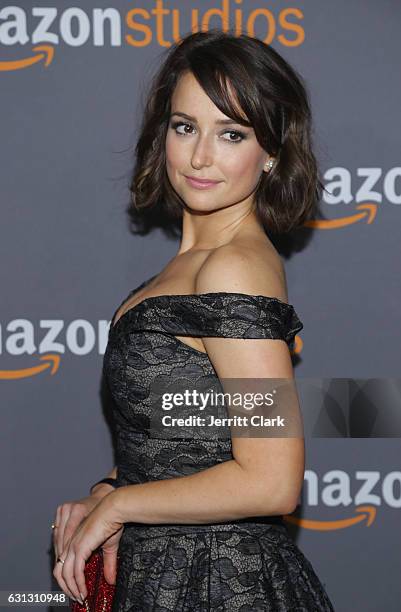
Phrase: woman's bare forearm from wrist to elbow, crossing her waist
[{"left": 110, "top": 438, "right": 303, "bottom": 524}]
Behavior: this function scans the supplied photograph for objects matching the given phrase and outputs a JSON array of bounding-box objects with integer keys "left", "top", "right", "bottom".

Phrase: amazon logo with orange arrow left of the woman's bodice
[{"left": 0, "top": 319, "right": 110, "bottom": 380}]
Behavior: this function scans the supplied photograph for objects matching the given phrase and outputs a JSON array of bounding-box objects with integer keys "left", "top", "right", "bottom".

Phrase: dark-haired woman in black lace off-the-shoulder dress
[{"left": 54, "top": 30, "right": 333, "bottom": 612}]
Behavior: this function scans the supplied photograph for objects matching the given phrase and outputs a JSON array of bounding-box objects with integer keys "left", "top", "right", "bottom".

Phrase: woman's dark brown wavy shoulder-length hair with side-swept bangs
[{"left": 130, "top": 29, "right": 324, "bottom": 234}]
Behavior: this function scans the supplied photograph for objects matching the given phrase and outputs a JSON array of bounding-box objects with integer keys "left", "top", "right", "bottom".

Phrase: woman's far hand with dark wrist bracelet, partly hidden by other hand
[{"left": 53, "top": 483, "right": 116, "bottom": 599}]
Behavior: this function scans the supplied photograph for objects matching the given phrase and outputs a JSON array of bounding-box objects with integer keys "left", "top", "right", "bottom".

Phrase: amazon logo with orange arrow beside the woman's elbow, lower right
[{"left": 284, "top": 470, "right": 401, "bottom": 531}]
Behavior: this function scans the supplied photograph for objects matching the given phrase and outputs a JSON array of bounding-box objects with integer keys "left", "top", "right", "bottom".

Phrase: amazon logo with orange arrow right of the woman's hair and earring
[{"left": 304, "top": 166, "right": 401, "bottom": 230}]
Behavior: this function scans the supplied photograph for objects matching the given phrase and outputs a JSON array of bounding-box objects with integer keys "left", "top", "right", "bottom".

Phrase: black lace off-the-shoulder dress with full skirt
[{"left": 104, "top": 277, "right": 333, "bottom": 612}]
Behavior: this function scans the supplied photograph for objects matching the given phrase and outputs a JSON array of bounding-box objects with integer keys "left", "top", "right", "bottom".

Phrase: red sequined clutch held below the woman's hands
[{"left": 70, "top": 548, "right": 115, "bottom": 612}]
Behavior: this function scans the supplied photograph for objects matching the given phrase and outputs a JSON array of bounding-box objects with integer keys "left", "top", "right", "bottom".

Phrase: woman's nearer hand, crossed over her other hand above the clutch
[{"left": 53, "top": 490, "right": 123, "bottom": 601}]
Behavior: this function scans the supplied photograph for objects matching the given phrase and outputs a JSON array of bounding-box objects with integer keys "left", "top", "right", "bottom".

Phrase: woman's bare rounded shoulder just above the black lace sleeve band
[{"left": 195, "top": 240, "right": 288, "bottom": 302}]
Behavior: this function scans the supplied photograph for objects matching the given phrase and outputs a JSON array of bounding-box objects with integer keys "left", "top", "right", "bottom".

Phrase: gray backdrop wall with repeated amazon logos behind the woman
[{"left": 0, "top": 0, "right": 401, "bottom": 612}]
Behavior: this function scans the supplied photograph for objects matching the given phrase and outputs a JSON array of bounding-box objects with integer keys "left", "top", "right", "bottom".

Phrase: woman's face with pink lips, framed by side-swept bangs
[{"left": 166, "top": 72, "right": 269, "bottom": 212}]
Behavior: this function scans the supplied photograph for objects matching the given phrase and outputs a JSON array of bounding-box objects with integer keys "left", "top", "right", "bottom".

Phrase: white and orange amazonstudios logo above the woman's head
[{"left": 0, "top": 0, "right": 305, "bottom": 71}]
